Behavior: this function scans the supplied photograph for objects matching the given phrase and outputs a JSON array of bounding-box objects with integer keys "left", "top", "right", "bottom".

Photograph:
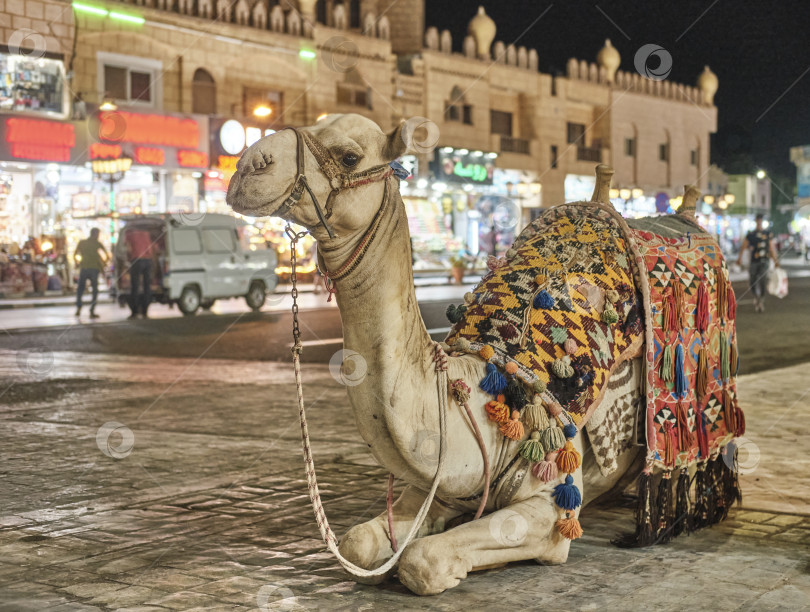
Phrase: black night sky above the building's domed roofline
[{"left": 425, "top": 0, "right": 810, "bottom": 185}]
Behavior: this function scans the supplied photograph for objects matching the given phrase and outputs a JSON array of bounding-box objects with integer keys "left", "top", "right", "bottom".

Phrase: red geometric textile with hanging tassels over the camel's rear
[{"left": 631, "top": 221, "right": 744, "bottom": 471}]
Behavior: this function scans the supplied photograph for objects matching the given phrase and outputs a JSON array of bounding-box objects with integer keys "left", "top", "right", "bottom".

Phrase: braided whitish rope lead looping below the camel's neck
[{"left": 292, "top": 328, "right": 448, "bottom": 578}]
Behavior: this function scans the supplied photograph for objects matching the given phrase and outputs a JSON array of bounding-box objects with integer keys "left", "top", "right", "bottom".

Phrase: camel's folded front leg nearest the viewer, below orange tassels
[{"left": 399, "top": 489, "right": 571, "bottom": 595}]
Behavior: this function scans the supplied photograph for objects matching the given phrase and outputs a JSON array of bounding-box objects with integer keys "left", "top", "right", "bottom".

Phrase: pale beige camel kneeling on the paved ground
[{"left": 227, "top": 114, "right": 736, "bottom": 595}]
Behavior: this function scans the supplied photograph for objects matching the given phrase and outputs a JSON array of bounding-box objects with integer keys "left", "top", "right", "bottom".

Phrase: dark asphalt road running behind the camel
[{"left": 0, "top": 276, "right": 810, "bottom": 373}]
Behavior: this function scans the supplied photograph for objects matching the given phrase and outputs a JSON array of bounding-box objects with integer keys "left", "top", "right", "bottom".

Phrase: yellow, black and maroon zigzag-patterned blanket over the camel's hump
[{"left": 446, "top": 203, "right": 644, "bottom": 423}]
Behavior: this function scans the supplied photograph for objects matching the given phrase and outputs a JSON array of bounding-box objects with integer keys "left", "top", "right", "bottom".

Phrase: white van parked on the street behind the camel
[{"left": 115, "top": 213, "right": 278, "bottom": 315}]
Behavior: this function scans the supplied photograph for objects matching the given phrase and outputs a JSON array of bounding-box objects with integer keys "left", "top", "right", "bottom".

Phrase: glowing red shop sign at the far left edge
[{"left": 6, "top": 117, "right": 76, "bottom": 162}]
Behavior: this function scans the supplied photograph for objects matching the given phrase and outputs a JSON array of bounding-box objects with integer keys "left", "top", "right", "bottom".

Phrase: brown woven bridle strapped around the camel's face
[{"left": 276, "top": 127, "right": 394, "bottom": 238}]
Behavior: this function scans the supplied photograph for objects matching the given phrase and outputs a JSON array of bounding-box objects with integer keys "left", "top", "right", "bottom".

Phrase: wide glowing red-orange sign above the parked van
[{"left": 98, "top": 111, "right": 200, "bottom": 149}]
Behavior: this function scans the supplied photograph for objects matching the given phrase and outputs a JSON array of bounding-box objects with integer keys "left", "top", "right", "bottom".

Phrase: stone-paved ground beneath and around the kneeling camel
[{"left": 0, "top": 352, "right": 810, "bottom": 612}]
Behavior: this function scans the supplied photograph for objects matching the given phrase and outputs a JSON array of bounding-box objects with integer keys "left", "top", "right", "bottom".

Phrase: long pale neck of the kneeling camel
[{"left": 323, "top": 179, "right": 438, "bottom": 473}]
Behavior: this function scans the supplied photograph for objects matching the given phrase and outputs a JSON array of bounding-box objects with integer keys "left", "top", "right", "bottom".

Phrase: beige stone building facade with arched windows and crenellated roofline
[{"left": 0, "top": 0, "right": 717, "bottom": 266}]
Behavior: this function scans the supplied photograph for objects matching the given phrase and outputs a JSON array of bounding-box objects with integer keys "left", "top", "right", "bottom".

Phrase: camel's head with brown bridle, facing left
[{"left": 227, "top": 114, "right": 407, "bottom": 239}]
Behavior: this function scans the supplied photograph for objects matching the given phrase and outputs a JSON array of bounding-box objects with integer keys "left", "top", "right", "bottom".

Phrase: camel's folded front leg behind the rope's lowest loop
[{"left": 338, "top": 486, "right": 462, "bottom": 584}]
